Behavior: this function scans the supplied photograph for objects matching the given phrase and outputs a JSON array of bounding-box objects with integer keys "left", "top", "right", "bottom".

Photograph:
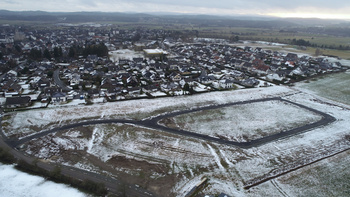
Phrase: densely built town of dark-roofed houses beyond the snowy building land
[{"left": 0, "top": 24, "right": 347, "bottom": 111}]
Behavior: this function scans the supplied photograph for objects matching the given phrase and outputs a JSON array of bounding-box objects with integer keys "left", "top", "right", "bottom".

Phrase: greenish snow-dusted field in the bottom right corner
[{"left": 278, "top": 151, "right": 350, "bottom": 197}]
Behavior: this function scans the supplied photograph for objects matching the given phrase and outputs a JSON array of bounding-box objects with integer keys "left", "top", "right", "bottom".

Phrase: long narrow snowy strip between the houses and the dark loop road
[{"left": 3, "top": 86, "right": 294, "bottom": 137}]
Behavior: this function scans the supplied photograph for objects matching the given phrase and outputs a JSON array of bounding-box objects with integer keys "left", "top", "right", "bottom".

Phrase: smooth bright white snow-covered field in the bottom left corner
[{"left": 0, "top": 163, "right": 87, "bottom": 197}]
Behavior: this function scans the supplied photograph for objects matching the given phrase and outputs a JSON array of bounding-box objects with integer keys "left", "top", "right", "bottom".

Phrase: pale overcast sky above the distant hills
[{"left": 0, "top": 0, "right": 350, "bottom": 19}]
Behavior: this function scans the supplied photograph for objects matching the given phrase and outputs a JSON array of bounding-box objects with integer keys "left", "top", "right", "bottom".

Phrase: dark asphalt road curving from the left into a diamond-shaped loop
[{"left": 8, "top": 97, "right": 336, "bottom": 148}]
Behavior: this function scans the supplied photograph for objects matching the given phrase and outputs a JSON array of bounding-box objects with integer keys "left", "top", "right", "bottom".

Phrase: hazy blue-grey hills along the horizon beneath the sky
[{"left": 0, "top": 10, "right": 348, "bottom": 28}]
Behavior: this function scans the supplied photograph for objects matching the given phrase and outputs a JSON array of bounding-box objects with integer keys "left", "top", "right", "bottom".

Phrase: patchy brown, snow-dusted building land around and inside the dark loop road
[{"left": 4, "top": 86, "right": 350, "bottom": 197}]
